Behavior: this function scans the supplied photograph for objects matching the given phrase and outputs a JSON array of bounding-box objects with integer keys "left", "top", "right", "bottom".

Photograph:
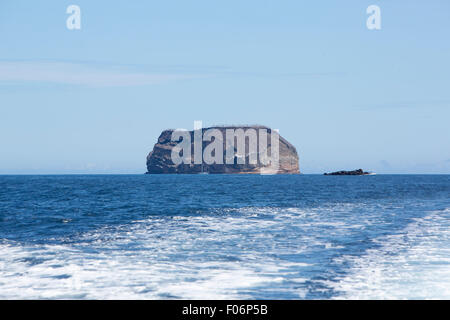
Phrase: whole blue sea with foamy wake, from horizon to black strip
[{"left": 0, "top": 175, "right": 450, "bottom": 299}]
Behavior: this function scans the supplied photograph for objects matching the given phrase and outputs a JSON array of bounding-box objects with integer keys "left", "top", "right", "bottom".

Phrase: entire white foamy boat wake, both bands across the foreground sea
[{"left": 0, "top": 203, "right": 450, "bottom": 299}]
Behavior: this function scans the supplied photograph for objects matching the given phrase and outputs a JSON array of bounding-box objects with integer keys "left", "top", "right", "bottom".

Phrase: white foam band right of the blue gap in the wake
[{"left": 333, "top": 208, "right": 450, "bottom": 299}]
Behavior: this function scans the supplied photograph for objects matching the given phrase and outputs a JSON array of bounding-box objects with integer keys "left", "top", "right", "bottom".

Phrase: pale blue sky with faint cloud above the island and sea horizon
[{"left": 0, "top": 0, "right": 450, "bottom": 174}]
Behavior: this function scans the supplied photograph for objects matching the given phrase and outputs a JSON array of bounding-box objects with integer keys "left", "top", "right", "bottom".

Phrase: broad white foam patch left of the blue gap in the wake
[{"left": 0, "top": 209, "right": 316, "bottom": 299}]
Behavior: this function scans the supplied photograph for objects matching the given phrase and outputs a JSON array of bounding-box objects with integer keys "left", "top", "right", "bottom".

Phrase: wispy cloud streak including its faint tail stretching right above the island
[{"left": 0, "top": 60, "right": 346, "bottom": 87}]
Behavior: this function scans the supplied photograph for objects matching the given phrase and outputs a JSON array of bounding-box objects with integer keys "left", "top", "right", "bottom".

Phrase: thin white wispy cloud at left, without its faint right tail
[{"left": 0, "top": 61, "right": 205, "bottom": 87}]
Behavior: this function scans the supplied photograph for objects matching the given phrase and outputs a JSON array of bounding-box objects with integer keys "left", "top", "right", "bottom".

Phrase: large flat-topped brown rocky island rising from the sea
[{"left": 147, "top": 126, "right": 300, "bottom": 174}]
